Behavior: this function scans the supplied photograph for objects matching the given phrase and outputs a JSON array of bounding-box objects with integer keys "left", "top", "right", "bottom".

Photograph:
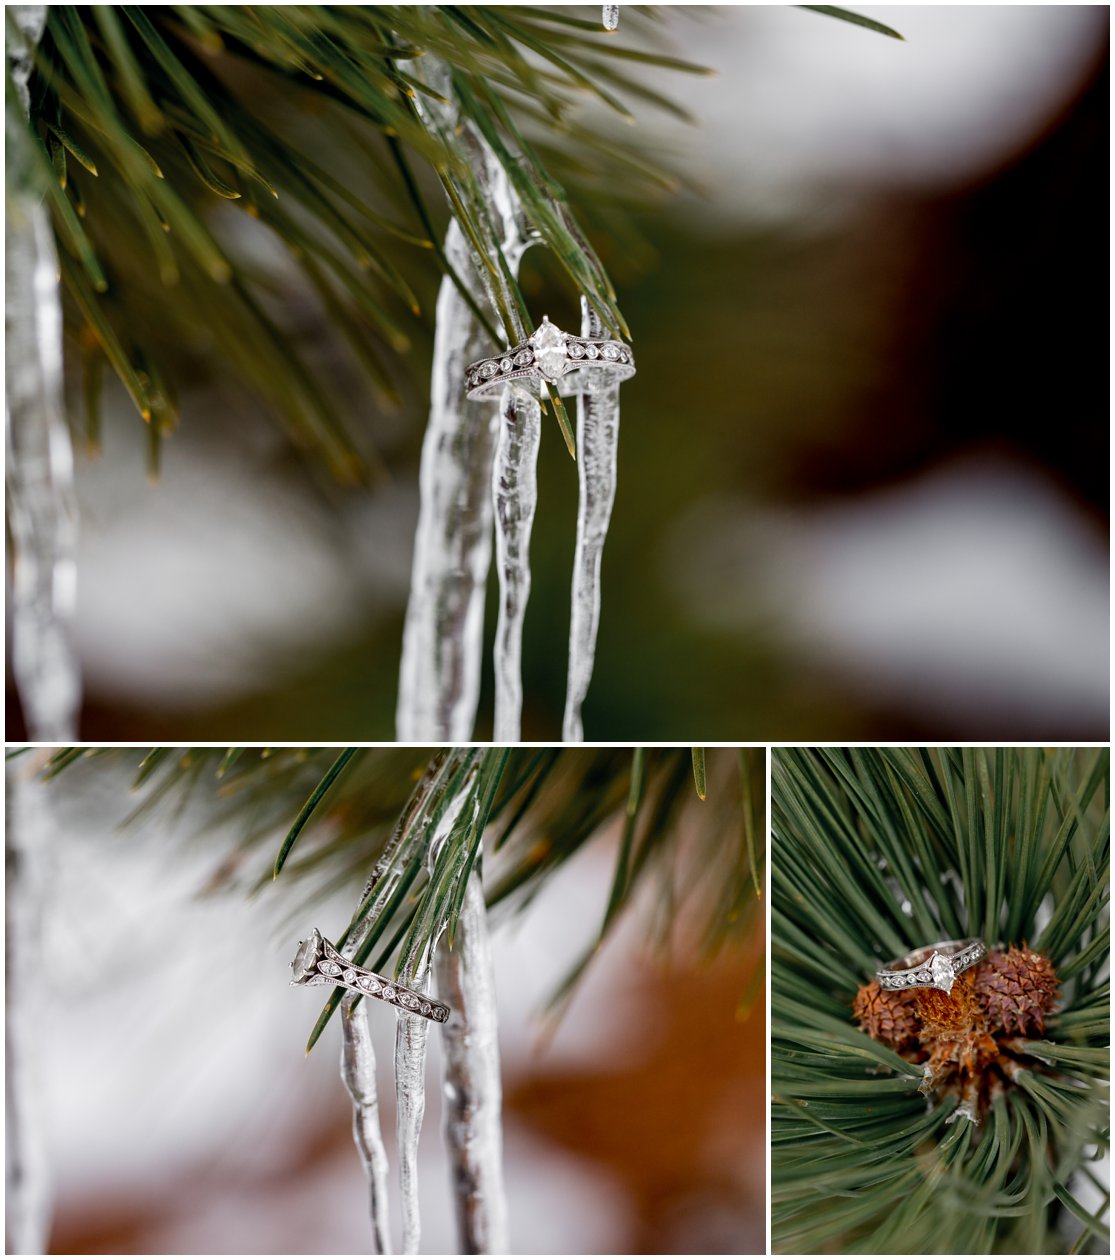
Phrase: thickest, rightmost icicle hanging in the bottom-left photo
[{"left": 437, "top": 857, "right": 510, "bottom": 1255}]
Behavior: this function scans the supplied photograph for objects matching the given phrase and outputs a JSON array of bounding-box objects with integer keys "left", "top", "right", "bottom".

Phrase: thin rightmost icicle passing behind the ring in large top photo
[{"left": 562, "top": 297, "right": 620, "bottom": 743}]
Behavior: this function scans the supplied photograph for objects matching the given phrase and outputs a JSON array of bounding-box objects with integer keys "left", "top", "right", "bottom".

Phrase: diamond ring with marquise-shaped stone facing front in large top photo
[{"left": 465, "top": 315, "right": 635, "bottom": 398}]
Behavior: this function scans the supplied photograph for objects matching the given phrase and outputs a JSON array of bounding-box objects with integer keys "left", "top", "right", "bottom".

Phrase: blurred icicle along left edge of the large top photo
[{"left": 4, "top": 5, "right": 81, "bottom": 742}]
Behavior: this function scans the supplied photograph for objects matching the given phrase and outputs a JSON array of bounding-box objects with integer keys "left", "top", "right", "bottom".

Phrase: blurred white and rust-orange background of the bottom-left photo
[{"left": 9, "top": 750, "right": 766, "bottom": 1255}]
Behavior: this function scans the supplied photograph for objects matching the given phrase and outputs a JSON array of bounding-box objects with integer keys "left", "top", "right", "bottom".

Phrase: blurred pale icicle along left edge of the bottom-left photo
[{"left": 4, "top": 757, "right": 52, "bottom": 1255}]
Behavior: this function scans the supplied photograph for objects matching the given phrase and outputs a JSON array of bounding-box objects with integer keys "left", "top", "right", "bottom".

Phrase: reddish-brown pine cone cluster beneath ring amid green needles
[{"left": 852, "top": 945, "right": 1057, "bottom": 1113}]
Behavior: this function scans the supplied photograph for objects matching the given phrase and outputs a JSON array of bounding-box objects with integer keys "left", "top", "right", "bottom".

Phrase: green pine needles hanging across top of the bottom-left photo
[{"left": 34, "top": 747, "right": 763, "bottom": 1045}]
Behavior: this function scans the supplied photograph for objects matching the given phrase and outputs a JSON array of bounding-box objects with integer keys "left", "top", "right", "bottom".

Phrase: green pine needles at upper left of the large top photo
[{"left": 13, "top": 5, "right": 700, "bottom": 480}]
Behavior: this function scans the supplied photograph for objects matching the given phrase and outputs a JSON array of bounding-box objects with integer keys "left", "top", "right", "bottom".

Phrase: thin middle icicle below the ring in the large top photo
[{"left": 491, "top": 384, "right": 542, "bottom": 743}]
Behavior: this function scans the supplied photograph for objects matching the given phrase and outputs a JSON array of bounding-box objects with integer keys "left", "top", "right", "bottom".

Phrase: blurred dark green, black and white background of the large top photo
[{"left": 8, "top": 5, "right": 1109, "bottom": 741}]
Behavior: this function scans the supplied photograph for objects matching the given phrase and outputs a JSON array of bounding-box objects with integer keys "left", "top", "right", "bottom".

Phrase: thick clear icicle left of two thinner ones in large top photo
[{"left": 396, "top": 55, "right": 532, "bottom": 741}]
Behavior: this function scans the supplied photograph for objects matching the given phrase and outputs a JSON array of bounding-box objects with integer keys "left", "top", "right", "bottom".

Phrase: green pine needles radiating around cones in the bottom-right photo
[{"left": 771, "top": 748, "right": 1110, "bottom": 1255}]
